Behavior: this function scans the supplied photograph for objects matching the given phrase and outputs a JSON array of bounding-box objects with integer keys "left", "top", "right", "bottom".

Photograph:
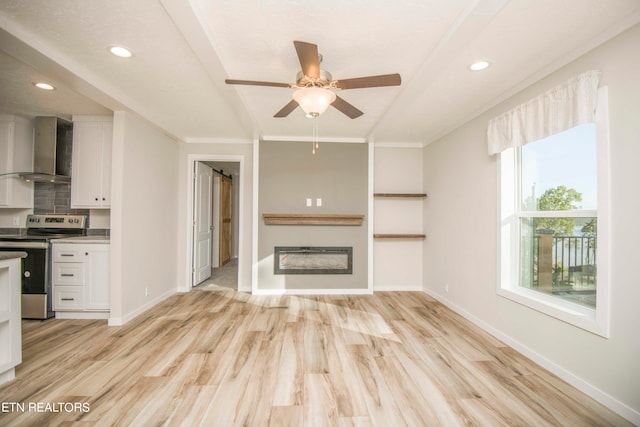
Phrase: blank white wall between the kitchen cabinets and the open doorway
[{"left": 109, "top": 111, "right": 180, "bottom": 325}]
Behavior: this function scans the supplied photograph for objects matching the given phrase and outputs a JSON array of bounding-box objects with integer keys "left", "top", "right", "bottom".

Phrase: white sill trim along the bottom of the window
[{"left": 497, "top": 288, "right": 609, "bottom": 338}]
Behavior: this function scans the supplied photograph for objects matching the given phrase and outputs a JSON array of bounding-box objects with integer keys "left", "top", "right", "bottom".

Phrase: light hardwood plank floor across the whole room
[{"left": 0, "top": 288, "right": 629, "bottom": 427}]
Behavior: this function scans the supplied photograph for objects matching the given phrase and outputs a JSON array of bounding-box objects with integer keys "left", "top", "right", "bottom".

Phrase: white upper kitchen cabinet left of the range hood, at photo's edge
[{"left": 0, "top": 115, "right": 33, "bottom": 208}]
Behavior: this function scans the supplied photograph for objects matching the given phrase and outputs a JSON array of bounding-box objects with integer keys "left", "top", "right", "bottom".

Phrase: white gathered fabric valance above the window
[{"left": 487, "top": 70, "right": 602, "bottom": 155}]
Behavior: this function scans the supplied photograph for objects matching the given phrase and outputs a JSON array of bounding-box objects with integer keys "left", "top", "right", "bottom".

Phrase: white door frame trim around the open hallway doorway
[{"left": 185, "top": 154, "right": 250, "bottom": 291}]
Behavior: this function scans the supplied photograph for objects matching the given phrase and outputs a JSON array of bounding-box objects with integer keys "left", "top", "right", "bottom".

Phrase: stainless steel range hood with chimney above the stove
[{"left": 18, "top": 117, "right": 73, "bottom": 183}]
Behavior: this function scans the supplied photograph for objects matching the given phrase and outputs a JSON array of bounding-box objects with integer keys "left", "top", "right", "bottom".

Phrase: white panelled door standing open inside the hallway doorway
[{"left": 193, "top": 162, "right": 213, "bottom": 286}]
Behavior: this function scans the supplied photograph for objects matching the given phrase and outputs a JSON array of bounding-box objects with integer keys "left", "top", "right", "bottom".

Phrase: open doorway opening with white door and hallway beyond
[{"left": 192, "top": 160, "right": 241, "bottom": 290}]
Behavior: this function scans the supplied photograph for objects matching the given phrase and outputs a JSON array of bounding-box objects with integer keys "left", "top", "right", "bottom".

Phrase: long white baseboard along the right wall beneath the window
[{"left": 422, "top": 289, "right": 640, "bottom": 425}]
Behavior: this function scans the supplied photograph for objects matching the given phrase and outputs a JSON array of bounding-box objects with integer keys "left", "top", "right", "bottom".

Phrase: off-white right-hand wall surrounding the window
[{"left": 424, "top": 22, "right": 640, "bottom": 423}]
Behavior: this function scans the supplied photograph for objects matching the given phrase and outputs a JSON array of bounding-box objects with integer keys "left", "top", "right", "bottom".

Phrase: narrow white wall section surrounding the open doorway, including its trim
[{"left": 176, "top": 142, "right": 253, "bottom": 291}]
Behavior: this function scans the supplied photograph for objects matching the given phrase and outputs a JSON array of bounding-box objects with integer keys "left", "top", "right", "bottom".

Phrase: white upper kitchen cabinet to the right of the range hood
[{"left": 71, "top": 116, "right": 113, "bottom": 209}]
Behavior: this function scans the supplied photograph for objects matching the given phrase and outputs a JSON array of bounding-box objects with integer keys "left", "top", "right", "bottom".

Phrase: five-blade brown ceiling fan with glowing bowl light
[{"left": 225, "top": 41, "right": 401, "bottom": 119}]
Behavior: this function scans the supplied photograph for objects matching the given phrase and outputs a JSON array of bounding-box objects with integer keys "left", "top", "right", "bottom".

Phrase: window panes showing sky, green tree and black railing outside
[{"left": 517, "top": 123, "right": 598, "bottom": 309}]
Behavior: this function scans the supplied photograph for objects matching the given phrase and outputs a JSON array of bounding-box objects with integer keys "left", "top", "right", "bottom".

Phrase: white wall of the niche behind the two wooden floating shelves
[{"left": 373, "top": 145, "right": 424, "bottom": 291}]
